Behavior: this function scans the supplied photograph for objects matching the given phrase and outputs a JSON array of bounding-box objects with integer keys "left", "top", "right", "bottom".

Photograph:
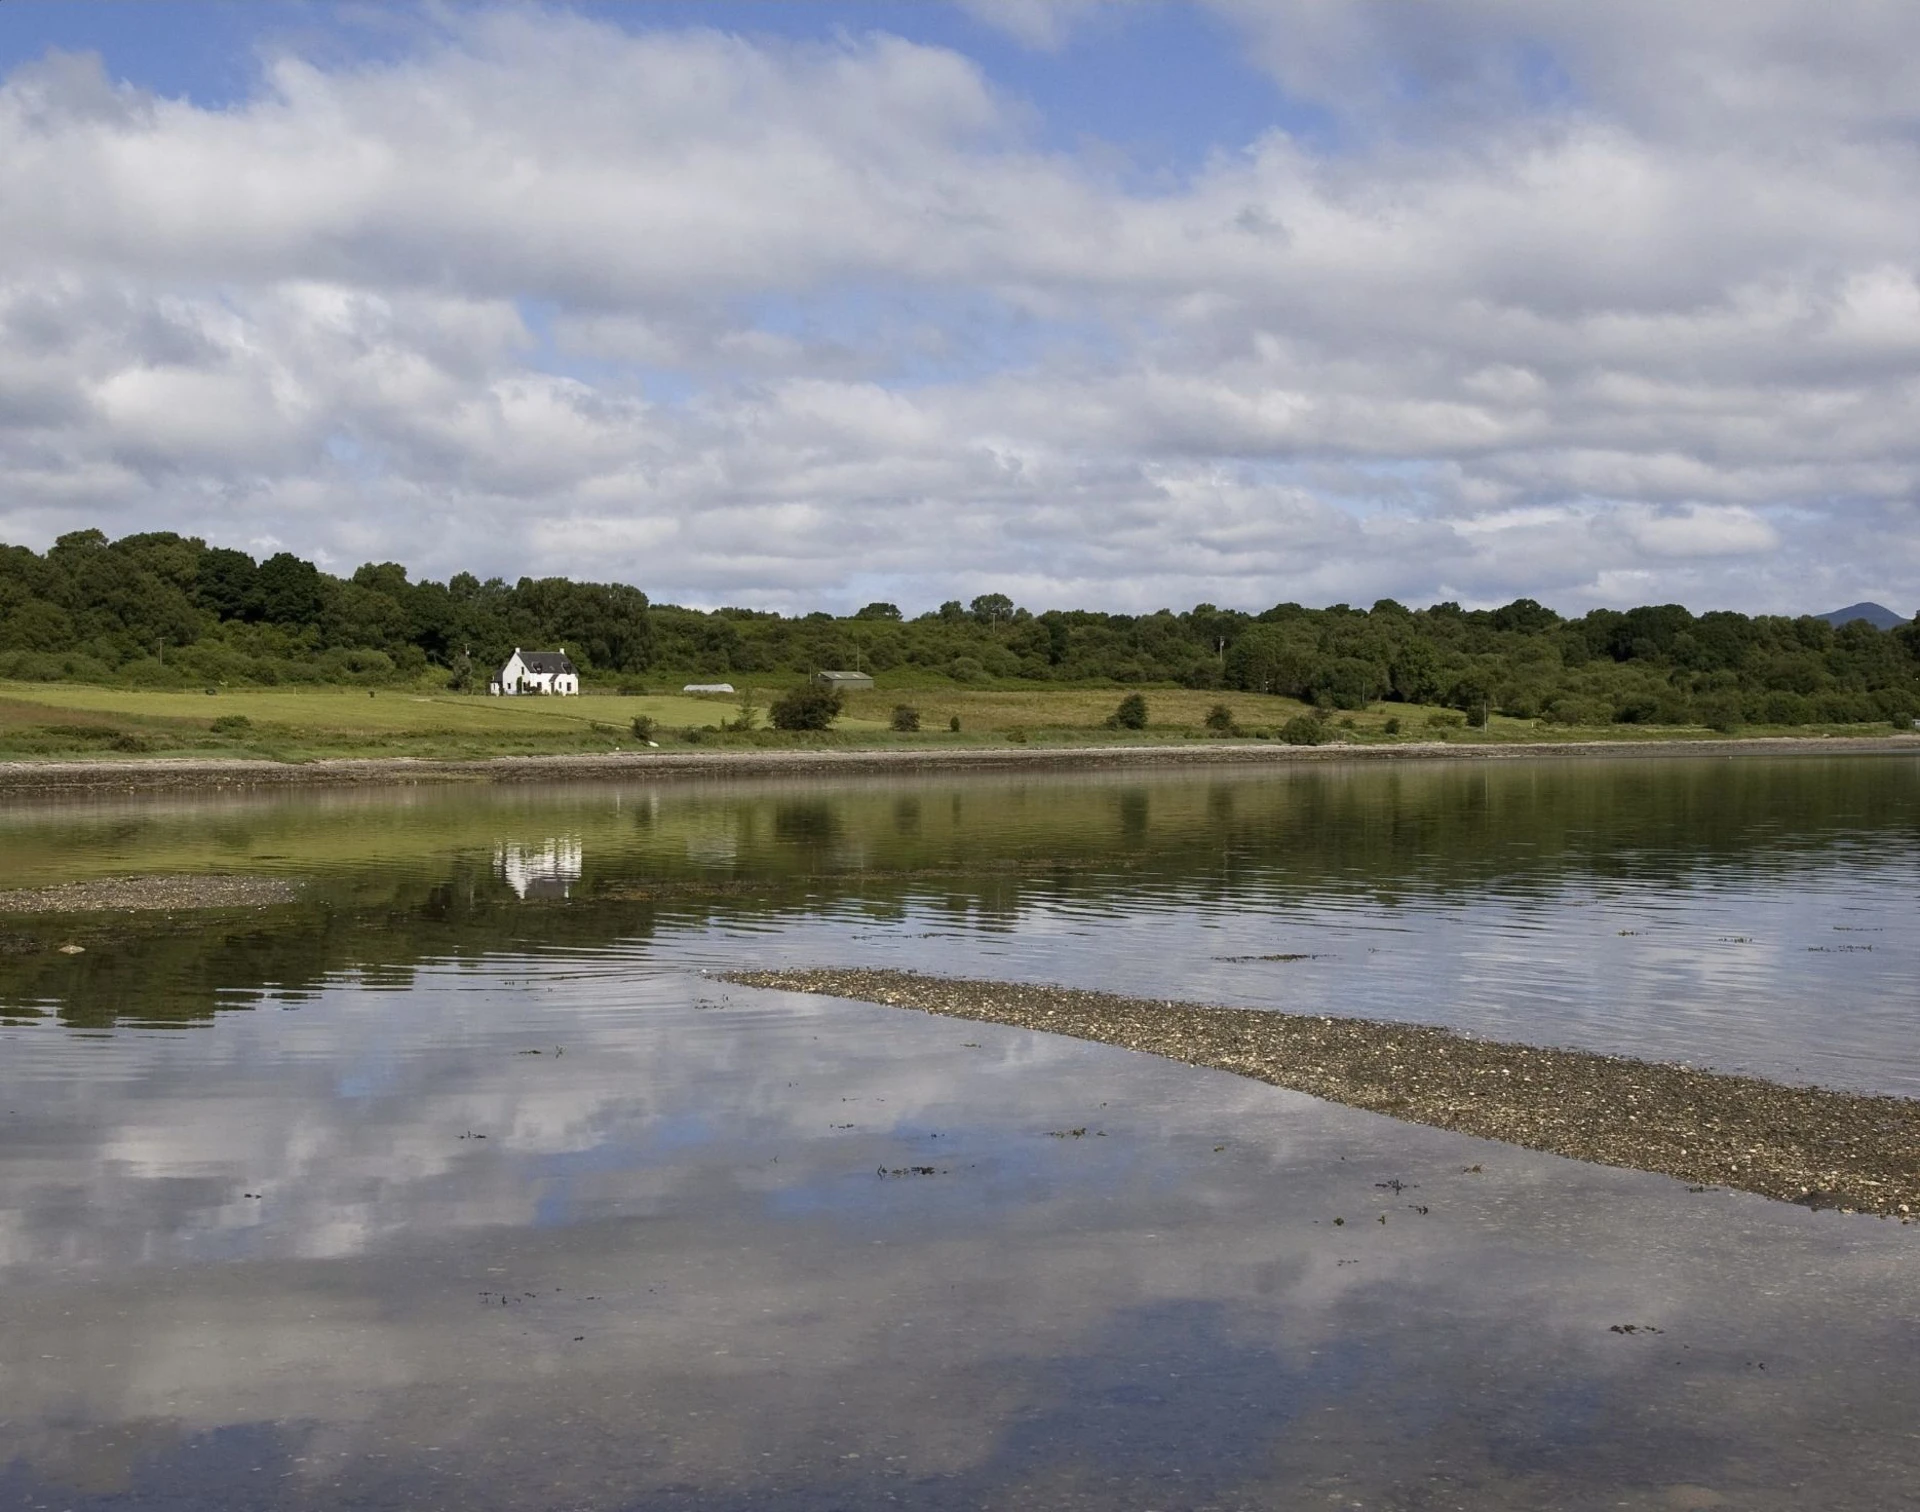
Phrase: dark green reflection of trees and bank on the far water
[{"left": 0, "top": 758, "right": 1920, "bottom": 1027}]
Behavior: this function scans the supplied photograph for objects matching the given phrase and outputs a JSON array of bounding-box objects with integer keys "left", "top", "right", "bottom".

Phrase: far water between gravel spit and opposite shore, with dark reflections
[{"left": 0, "top": 756, "right": 1920, "bottom": 1092}]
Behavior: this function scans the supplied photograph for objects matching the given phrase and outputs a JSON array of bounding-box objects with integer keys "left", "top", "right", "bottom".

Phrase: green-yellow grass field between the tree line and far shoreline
[{"left": 0, "top": 683, "right": 1884, "bottom": 762}]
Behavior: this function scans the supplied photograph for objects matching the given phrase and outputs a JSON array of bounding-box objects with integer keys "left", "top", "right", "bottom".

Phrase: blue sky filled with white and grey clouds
[{"left": 0, "top": 0, "right": 1920, "bottom": 614}]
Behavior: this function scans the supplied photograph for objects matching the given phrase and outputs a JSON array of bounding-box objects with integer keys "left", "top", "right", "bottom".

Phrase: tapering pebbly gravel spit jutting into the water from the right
[{"left": 718, "top": 969, "right": 1920, "bottom": 1222}]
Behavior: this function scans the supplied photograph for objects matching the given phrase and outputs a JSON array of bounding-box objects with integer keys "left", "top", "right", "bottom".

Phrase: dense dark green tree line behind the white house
[{"left": 0, "top": 530, "right": 1920, "bottom": 727}]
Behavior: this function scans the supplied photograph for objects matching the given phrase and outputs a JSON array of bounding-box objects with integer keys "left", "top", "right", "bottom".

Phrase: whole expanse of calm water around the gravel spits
[{"left": 0, "top": 756, "right": 1920, "bottom": 1508}]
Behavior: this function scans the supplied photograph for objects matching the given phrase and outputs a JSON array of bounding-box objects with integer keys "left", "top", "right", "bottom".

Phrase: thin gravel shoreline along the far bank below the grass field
[{"left": 0, "top": 735, "right": 1920, "bottom": 798}]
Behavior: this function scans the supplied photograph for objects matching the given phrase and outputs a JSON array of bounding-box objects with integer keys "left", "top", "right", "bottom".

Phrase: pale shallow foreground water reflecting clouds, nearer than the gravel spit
[{"left": 0, "top": 954, "right": 1920, "bottom": 1510}]
